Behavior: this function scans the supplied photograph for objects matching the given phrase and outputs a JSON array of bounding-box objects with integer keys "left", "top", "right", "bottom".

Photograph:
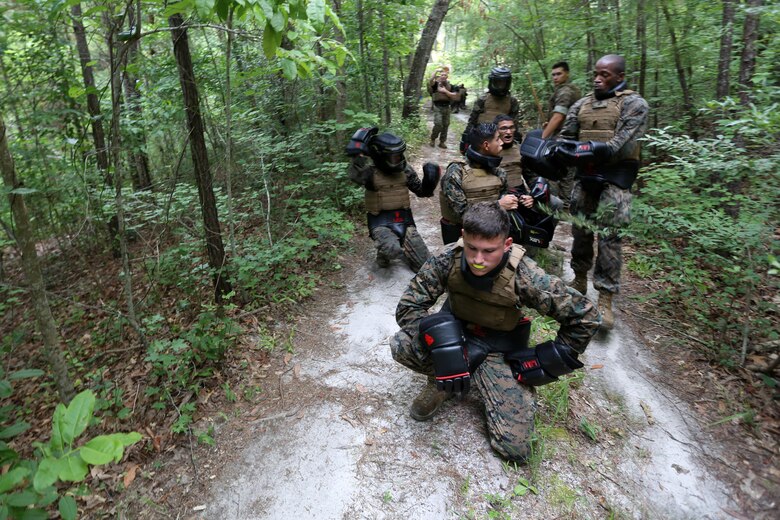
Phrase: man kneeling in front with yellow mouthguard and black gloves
[{"left": 390, "top": 202, "right": 601, "bottom": 462}]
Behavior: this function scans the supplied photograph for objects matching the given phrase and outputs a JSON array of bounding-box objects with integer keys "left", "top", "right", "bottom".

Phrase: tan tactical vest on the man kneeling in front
[{"left": 447, "top": 239, "right": 525, "bottom": 331}]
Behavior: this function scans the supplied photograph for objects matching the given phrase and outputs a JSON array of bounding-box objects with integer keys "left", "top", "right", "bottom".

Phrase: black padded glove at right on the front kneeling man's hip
[{"left": 504, "top": 341, "right": 584, "bottom": 386}]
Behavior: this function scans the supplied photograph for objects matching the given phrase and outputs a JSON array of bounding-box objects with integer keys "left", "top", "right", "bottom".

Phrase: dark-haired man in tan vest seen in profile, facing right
[{"left": 439, "top": 123, "right": 516, "bottom": 244}]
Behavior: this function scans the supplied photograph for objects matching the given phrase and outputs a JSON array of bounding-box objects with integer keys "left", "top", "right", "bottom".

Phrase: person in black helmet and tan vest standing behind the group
[{"left": 460, "top": 67, "right": 523, "bottom": 153}]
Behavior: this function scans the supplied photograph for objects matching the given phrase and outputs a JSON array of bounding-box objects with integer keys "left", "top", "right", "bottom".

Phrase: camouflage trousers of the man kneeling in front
[{"left": 390, "top": 330, "right": 536, "bottom": 463}]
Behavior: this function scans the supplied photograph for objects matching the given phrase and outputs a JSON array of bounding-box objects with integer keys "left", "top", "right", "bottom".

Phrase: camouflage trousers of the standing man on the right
[{"left": 571, "top": 181, "right": 631, "bottom": 294}]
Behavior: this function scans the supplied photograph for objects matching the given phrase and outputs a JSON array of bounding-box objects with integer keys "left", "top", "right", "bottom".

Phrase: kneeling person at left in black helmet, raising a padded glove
[{"left": 346, "top": 127, "right": 441, "bottom": 272}]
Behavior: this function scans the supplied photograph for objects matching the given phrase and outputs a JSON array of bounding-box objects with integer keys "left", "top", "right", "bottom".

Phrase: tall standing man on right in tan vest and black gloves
[{"left": 554, "top": 54, "right": 649, "bottom": 329}]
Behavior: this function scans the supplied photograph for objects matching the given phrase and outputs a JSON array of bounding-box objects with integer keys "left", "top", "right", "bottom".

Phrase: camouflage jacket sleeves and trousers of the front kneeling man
[{"left": 390, "top": 245, "right": 601, "bottom": 462}]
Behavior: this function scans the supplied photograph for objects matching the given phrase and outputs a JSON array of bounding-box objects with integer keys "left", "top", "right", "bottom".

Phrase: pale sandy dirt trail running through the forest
[{"left": 180, "top": 116, "right": 739, "bottom": 519}]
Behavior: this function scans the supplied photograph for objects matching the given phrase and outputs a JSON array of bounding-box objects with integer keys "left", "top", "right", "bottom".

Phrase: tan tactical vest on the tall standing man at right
[{"left": 577, "top": 90, "right": 640, "bottom": 163}]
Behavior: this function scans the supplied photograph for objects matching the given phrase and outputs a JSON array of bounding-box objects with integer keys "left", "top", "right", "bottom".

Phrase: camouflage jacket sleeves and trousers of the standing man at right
[{"left": 560, "top": 91, "right": 649, "bottom": 294}]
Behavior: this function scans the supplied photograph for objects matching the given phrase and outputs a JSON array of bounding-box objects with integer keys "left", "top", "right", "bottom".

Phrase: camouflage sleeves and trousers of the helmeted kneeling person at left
[{"left": 348, "top": 156, "right": 430, "bottom": 272}]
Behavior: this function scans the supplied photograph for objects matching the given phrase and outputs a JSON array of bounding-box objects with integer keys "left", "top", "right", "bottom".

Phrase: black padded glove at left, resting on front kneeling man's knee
[{"left": 420, "top": 312, "right": 471, "bottom": 394}]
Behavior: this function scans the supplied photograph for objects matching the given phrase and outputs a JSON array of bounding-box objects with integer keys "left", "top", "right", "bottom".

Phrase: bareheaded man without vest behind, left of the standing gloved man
[{"left": 542, "top": 61, "right": 582, "bottom": 211}]
